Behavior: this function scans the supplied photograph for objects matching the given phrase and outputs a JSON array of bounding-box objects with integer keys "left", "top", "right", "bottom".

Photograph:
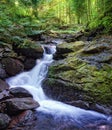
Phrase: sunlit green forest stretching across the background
[{"left": 0, "top": 0, "right": 112, "bottom": 33}]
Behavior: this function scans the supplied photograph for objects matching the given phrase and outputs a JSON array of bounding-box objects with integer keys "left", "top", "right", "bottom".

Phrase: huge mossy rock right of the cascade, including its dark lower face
[{"left": 43, "top": 39, "right": 112, "bottom": 113}]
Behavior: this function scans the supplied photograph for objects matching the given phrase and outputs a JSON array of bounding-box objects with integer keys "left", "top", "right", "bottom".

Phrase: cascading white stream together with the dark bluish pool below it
[{"left": 6, "top": 45, "right": 111, "bottom": 130}]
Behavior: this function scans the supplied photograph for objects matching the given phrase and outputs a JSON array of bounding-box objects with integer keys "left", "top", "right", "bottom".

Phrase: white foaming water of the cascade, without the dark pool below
[{"left": 6, "top": 45, "right": 111, "bottom": 127}]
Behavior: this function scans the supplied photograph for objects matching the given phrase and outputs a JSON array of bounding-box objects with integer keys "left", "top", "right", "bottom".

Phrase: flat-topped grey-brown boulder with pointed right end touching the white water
[{"left": 1, "top": 97, "right": 39, "bottom": 115}]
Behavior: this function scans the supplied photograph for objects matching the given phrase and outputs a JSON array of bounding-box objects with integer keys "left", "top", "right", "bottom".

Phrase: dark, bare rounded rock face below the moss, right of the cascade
[{"left": 43, "top": 78, "right": 83, "bottom": 103}]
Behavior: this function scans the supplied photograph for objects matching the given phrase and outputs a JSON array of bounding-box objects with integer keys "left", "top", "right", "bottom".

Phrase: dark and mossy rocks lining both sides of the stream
[{"left": 0, "top": 30, "right": 112, "bottom": 130}]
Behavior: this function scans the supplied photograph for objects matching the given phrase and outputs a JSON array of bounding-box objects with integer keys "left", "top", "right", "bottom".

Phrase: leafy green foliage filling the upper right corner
[{"left": 89, "top": 0, "right": 112, "bottom": 33}]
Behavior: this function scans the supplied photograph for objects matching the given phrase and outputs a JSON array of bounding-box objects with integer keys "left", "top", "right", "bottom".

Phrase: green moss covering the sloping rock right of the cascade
[{"left": 49, "top": 51, "right": 112, "bottom": 105}]
